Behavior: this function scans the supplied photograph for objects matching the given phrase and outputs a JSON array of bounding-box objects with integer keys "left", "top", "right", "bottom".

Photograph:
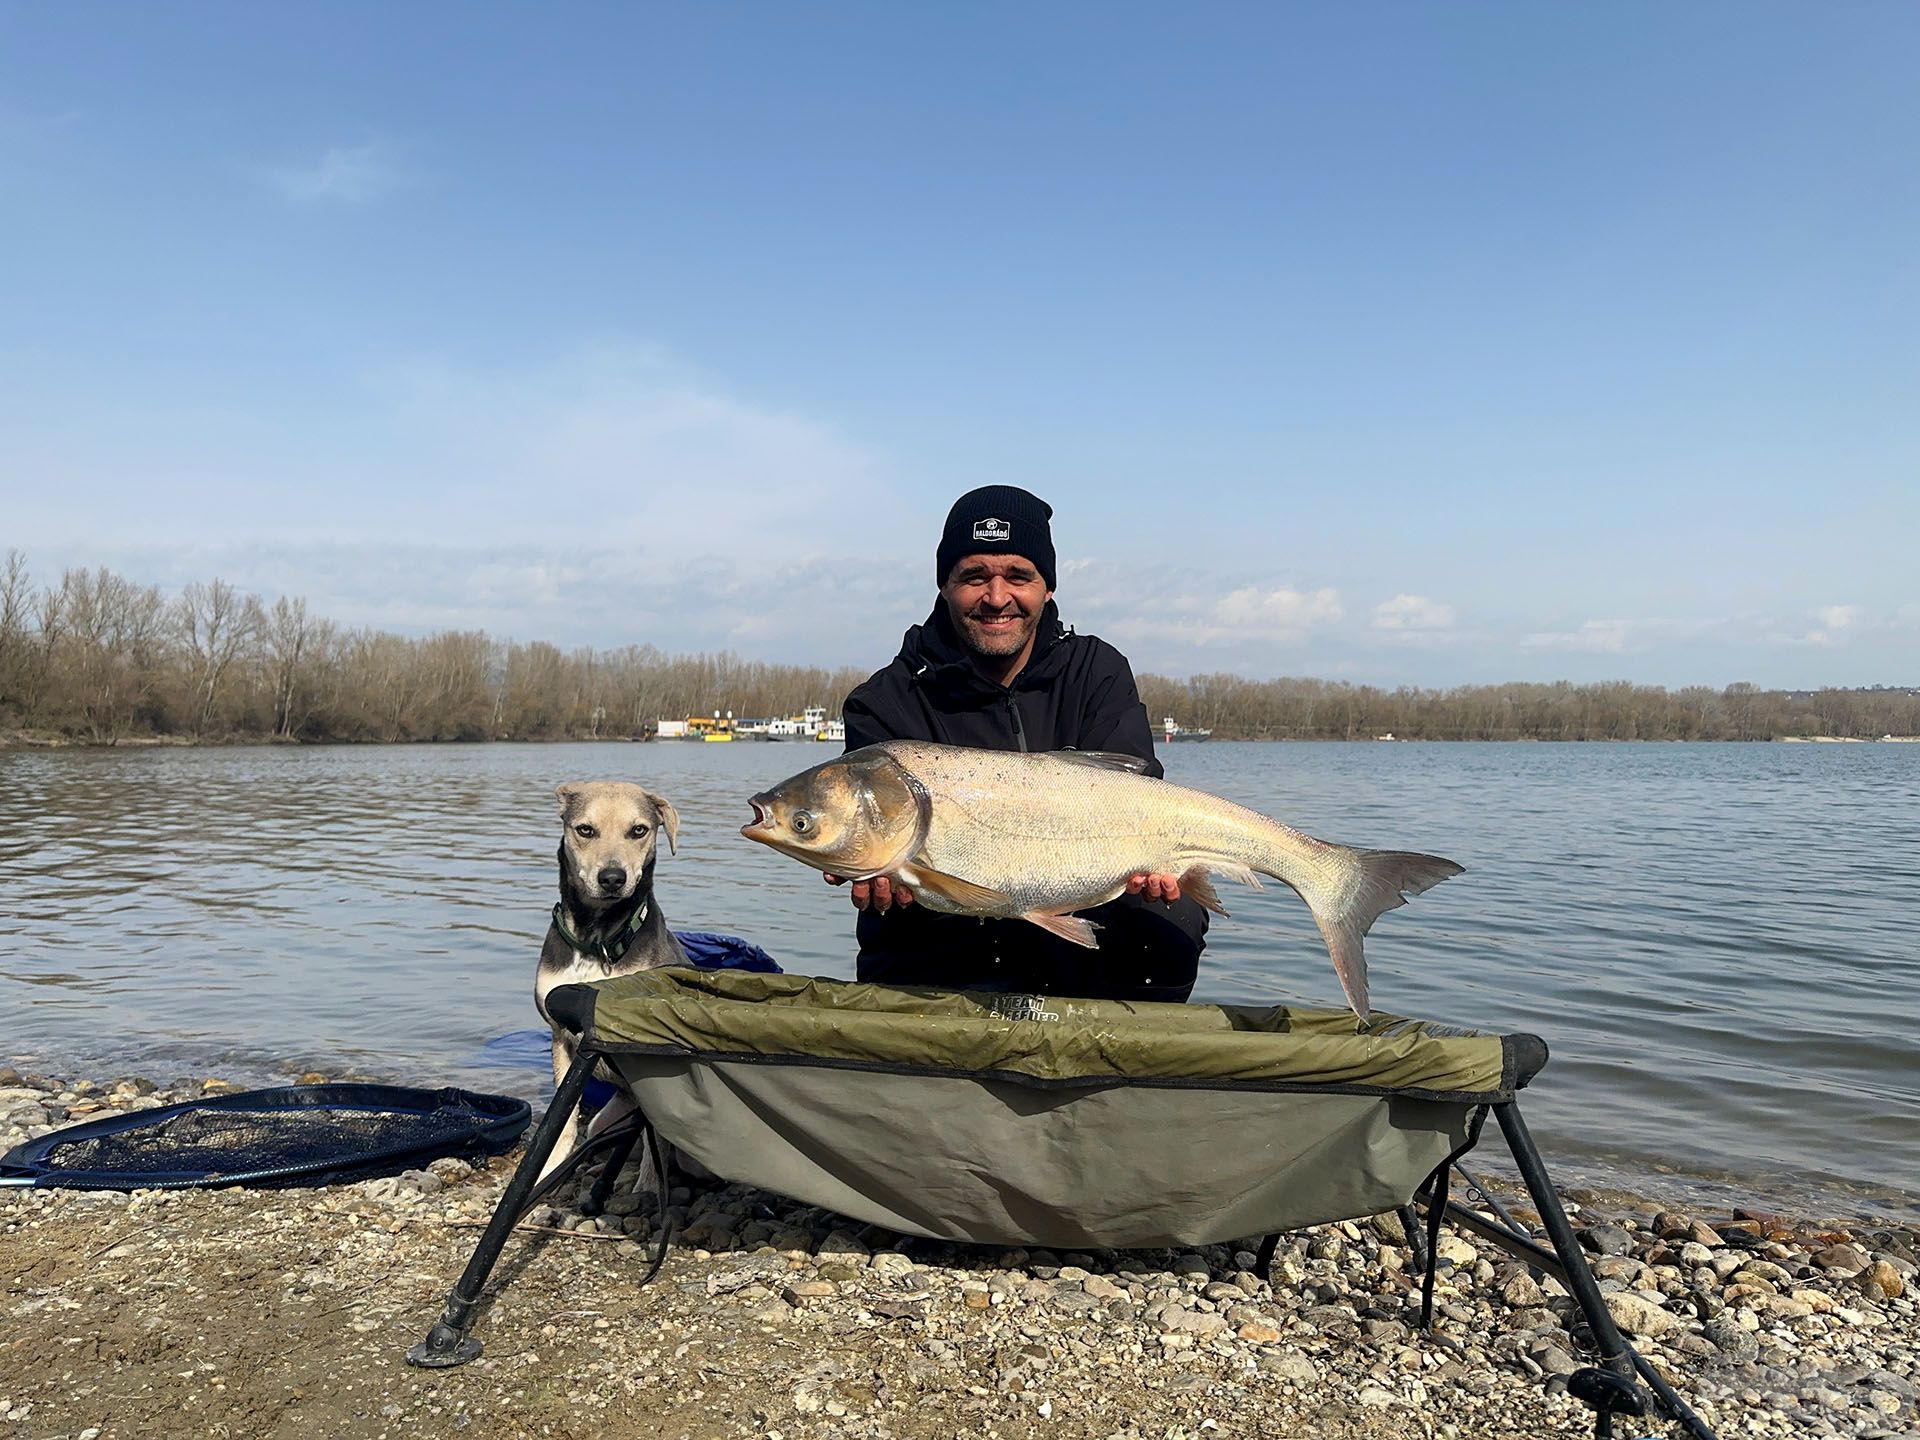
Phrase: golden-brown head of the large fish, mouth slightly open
[{"left": 739, "top": 745, "right": 931, "bottom": 879}]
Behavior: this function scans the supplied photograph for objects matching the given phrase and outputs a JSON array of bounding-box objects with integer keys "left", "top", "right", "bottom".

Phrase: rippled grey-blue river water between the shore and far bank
[{"left": 0, "top": 743, "right": 1920, "bottom": 1221}]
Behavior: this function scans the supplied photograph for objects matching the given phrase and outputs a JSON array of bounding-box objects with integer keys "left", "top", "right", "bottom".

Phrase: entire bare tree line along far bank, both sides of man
[{"left": 0, "top": 551, "right": 1920, "bottom": 745}]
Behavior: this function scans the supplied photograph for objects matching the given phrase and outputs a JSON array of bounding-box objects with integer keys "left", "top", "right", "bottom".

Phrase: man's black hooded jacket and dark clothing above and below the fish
[{"left": 841, "top": 601, "right": 1206, "bottom": 1000}]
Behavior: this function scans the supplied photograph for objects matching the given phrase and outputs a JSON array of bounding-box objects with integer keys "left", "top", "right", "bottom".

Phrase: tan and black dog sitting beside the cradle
[{"left": 534, "top": 780, "right": 687, "bottom": 1179}]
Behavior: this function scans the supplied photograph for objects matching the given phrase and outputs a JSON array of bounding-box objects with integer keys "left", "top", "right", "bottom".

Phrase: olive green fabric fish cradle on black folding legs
[{"left": 409, "top": 968, "right": 1711, "bottom": 1436}]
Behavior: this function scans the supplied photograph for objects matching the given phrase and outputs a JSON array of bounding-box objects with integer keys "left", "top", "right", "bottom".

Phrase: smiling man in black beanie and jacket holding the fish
[{"left": 828, "top": 486, "right": 1206, "bottom": 1000}]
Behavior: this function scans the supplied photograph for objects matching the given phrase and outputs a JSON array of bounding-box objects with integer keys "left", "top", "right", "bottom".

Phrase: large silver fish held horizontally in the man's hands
[{"left": 741, "top": 739, "right": 1461, "bottom": 1016}]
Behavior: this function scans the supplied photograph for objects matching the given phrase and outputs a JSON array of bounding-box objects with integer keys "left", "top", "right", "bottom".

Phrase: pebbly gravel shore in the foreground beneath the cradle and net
[{"left": 0, "top": 1069, "right": 1920, "bottom": 1440}]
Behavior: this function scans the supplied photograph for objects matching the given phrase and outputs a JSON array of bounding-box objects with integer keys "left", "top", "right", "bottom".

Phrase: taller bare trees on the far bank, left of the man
[{"left": 0, "top": 551, "right": 866, "bottom": 745}]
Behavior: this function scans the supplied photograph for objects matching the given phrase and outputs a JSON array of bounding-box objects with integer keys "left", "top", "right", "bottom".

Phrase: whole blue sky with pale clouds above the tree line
[{"left": 0, "top": 4, "right": 1920, "bottom": 685}]
